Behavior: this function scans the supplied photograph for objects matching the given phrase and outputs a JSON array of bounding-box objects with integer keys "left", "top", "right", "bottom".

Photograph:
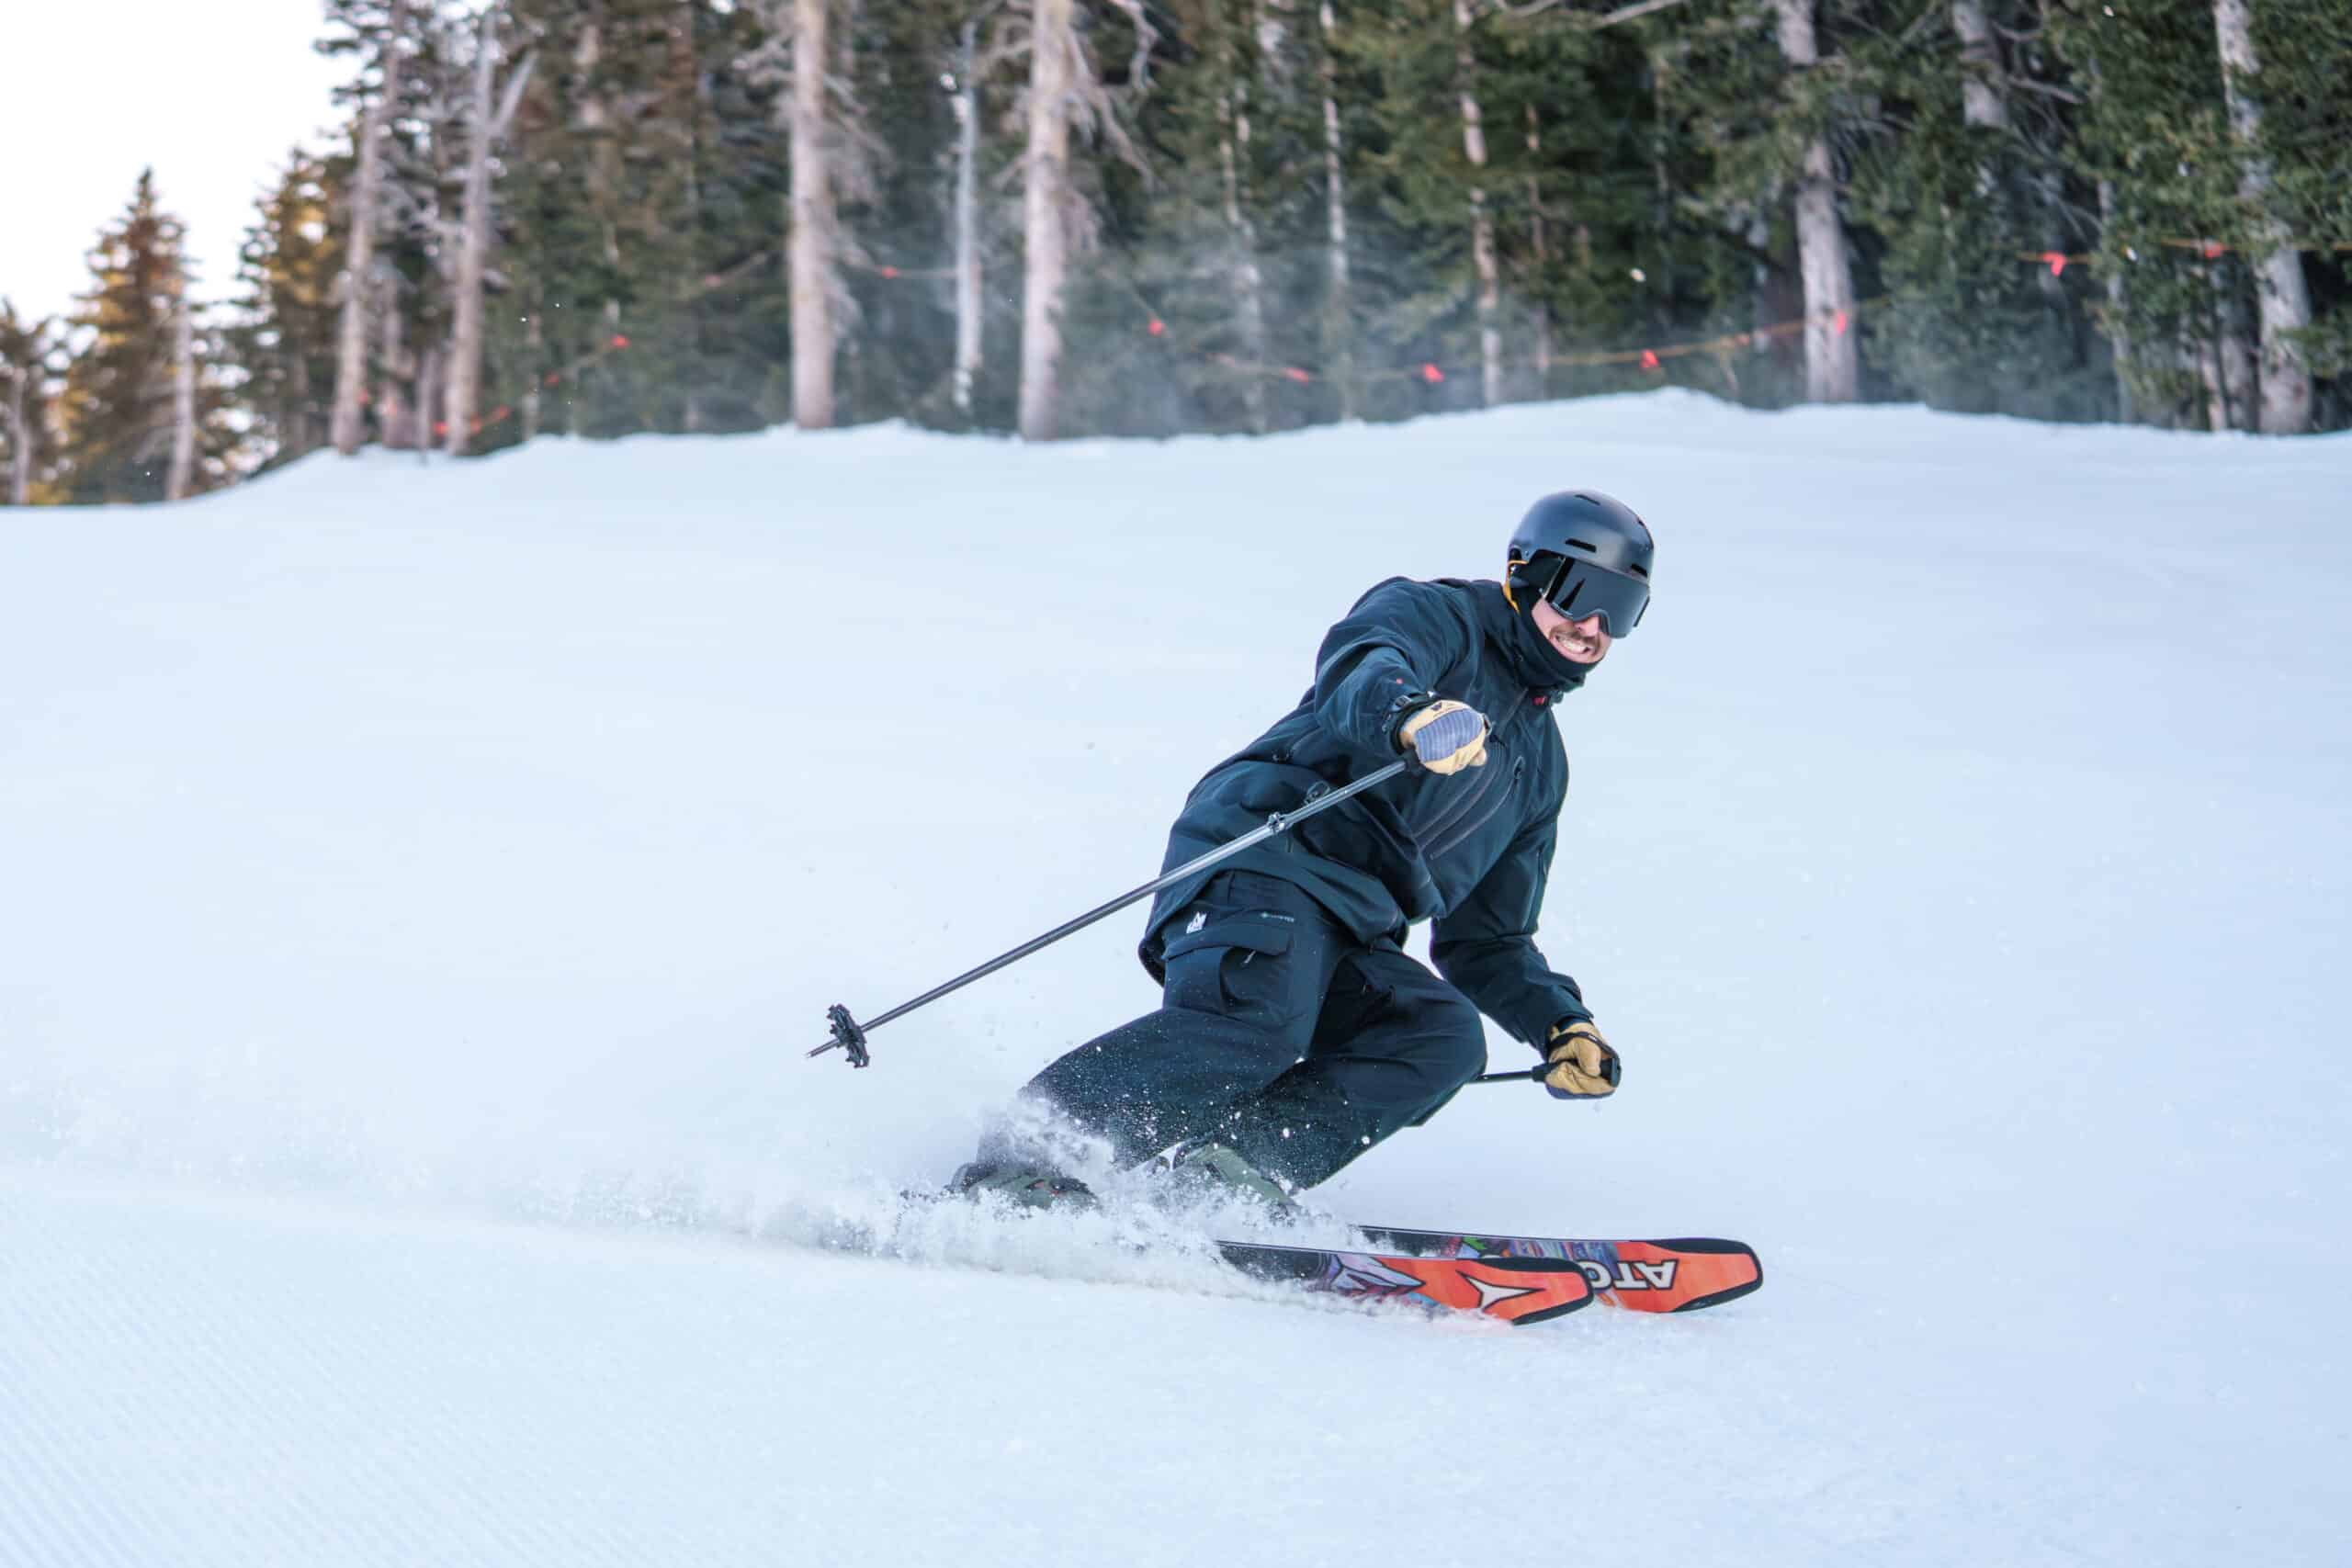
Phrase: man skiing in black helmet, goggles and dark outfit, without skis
[{"left": 953, "top": 491, "right": 1654, "bottom": 1213}]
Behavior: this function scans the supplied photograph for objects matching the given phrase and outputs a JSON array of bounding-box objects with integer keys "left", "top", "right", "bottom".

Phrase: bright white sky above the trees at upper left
[{"left": 0, "top": 0, "right": 350, "bottom": 329}]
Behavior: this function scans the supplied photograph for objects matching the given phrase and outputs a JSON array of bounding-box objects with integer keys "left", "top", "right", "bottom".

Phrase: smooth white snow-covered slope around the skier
[{"left": 0, "top": 395, "right": 2352, "bottom": 1568}]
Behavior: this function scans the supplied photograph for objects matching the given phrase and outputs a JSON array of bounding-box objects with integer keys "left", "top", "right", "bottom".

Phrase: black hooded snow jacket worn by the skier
[{"left": 1141, "top": 579, "right": 1590, "bottom": 1043}]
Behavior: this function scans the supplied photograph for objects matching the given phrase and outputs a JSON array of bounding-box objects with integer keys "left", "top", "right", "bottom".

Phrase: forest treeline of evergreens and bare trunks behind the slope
[{"left": 0, "top": 0, "right": 2352, "bottom": 503}]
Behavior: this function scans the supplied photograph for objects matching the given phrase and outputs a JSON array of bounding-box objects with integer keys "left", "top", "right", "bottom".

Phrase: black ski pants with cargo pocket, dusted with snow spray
[{"left": 1023, "top": 872, "right": 1487, "bottom": 1187}]
